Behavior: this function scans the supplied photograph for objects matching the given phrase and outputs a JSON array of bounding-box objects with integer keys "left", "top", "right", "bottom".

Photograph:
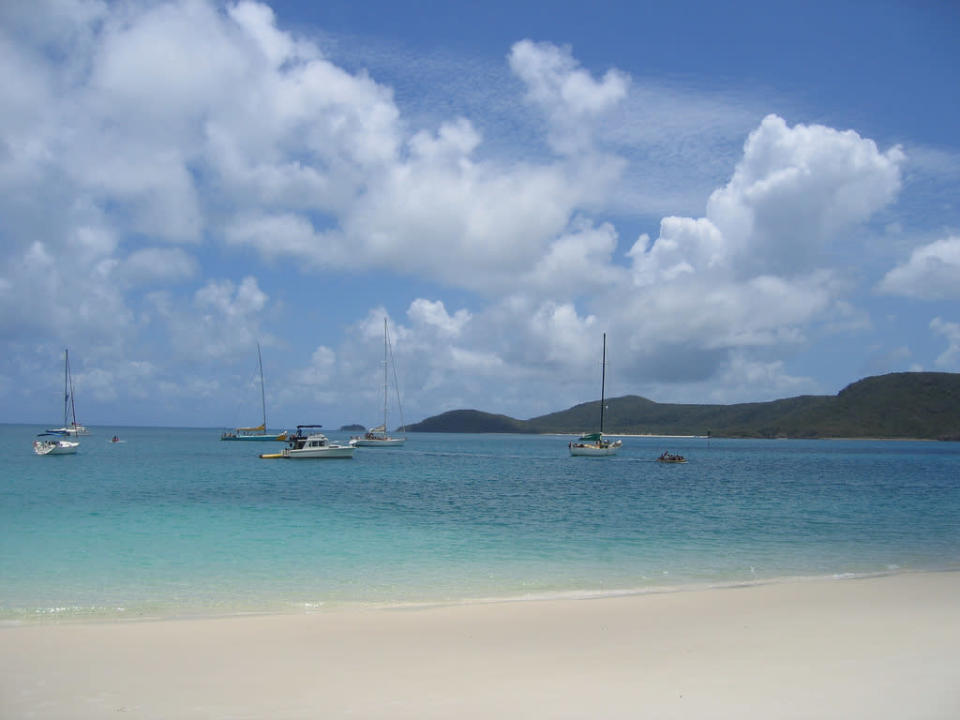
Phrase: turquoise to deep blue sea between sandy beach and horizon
[{"left": 0, "top": 425, "right": 960, "bottom": 621}]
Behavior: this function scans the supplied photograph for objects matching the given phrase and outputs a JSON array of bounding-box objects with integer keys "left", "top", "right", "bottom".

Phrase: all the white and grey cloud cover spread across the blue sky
[{"left": 0, "top": 0, "right": 960, "bottom": 428}]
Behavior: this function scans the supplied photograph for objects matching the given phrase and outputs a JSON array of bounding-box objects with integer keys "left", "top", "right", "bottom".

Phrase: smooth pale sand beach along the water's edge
[{"left": 0, "top": 572, "right": 960, "bottom": 719}]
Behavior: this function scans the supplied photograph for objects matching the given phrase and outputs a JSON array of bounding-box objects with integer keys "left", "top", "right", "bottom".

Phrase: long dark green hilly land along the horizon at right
[{"left": 407, "top": 372, "right": 960, "bottom": 441}]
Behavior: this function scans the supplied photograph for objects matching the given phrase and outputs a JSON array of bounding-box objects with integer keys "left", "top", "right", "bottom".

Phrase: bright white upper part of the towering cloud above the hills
[{"left": 630, "top": 115, "right": 903, "bottom": 286}]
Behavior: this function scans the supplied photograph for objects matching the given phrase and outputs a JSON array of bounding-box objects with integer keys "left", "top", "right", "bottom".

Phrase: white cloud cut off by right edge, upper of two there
[{"left": 878, "top": 237, "right": 960, "bottom": 300}]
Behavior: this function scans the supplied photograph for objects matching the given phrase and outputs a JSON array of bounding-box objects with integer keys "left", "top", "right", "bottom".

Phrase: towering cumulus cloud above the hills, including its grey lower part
[{"left": 609, "top": 115, "right": 903, "bottom": 390}]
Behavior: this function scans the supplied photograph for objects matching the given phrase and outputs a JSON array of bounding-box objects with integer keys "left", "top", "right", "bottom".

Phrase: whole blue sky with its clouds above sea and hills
[{"left": 0, "top": 0, "right": 960, "bottom": 428}]
